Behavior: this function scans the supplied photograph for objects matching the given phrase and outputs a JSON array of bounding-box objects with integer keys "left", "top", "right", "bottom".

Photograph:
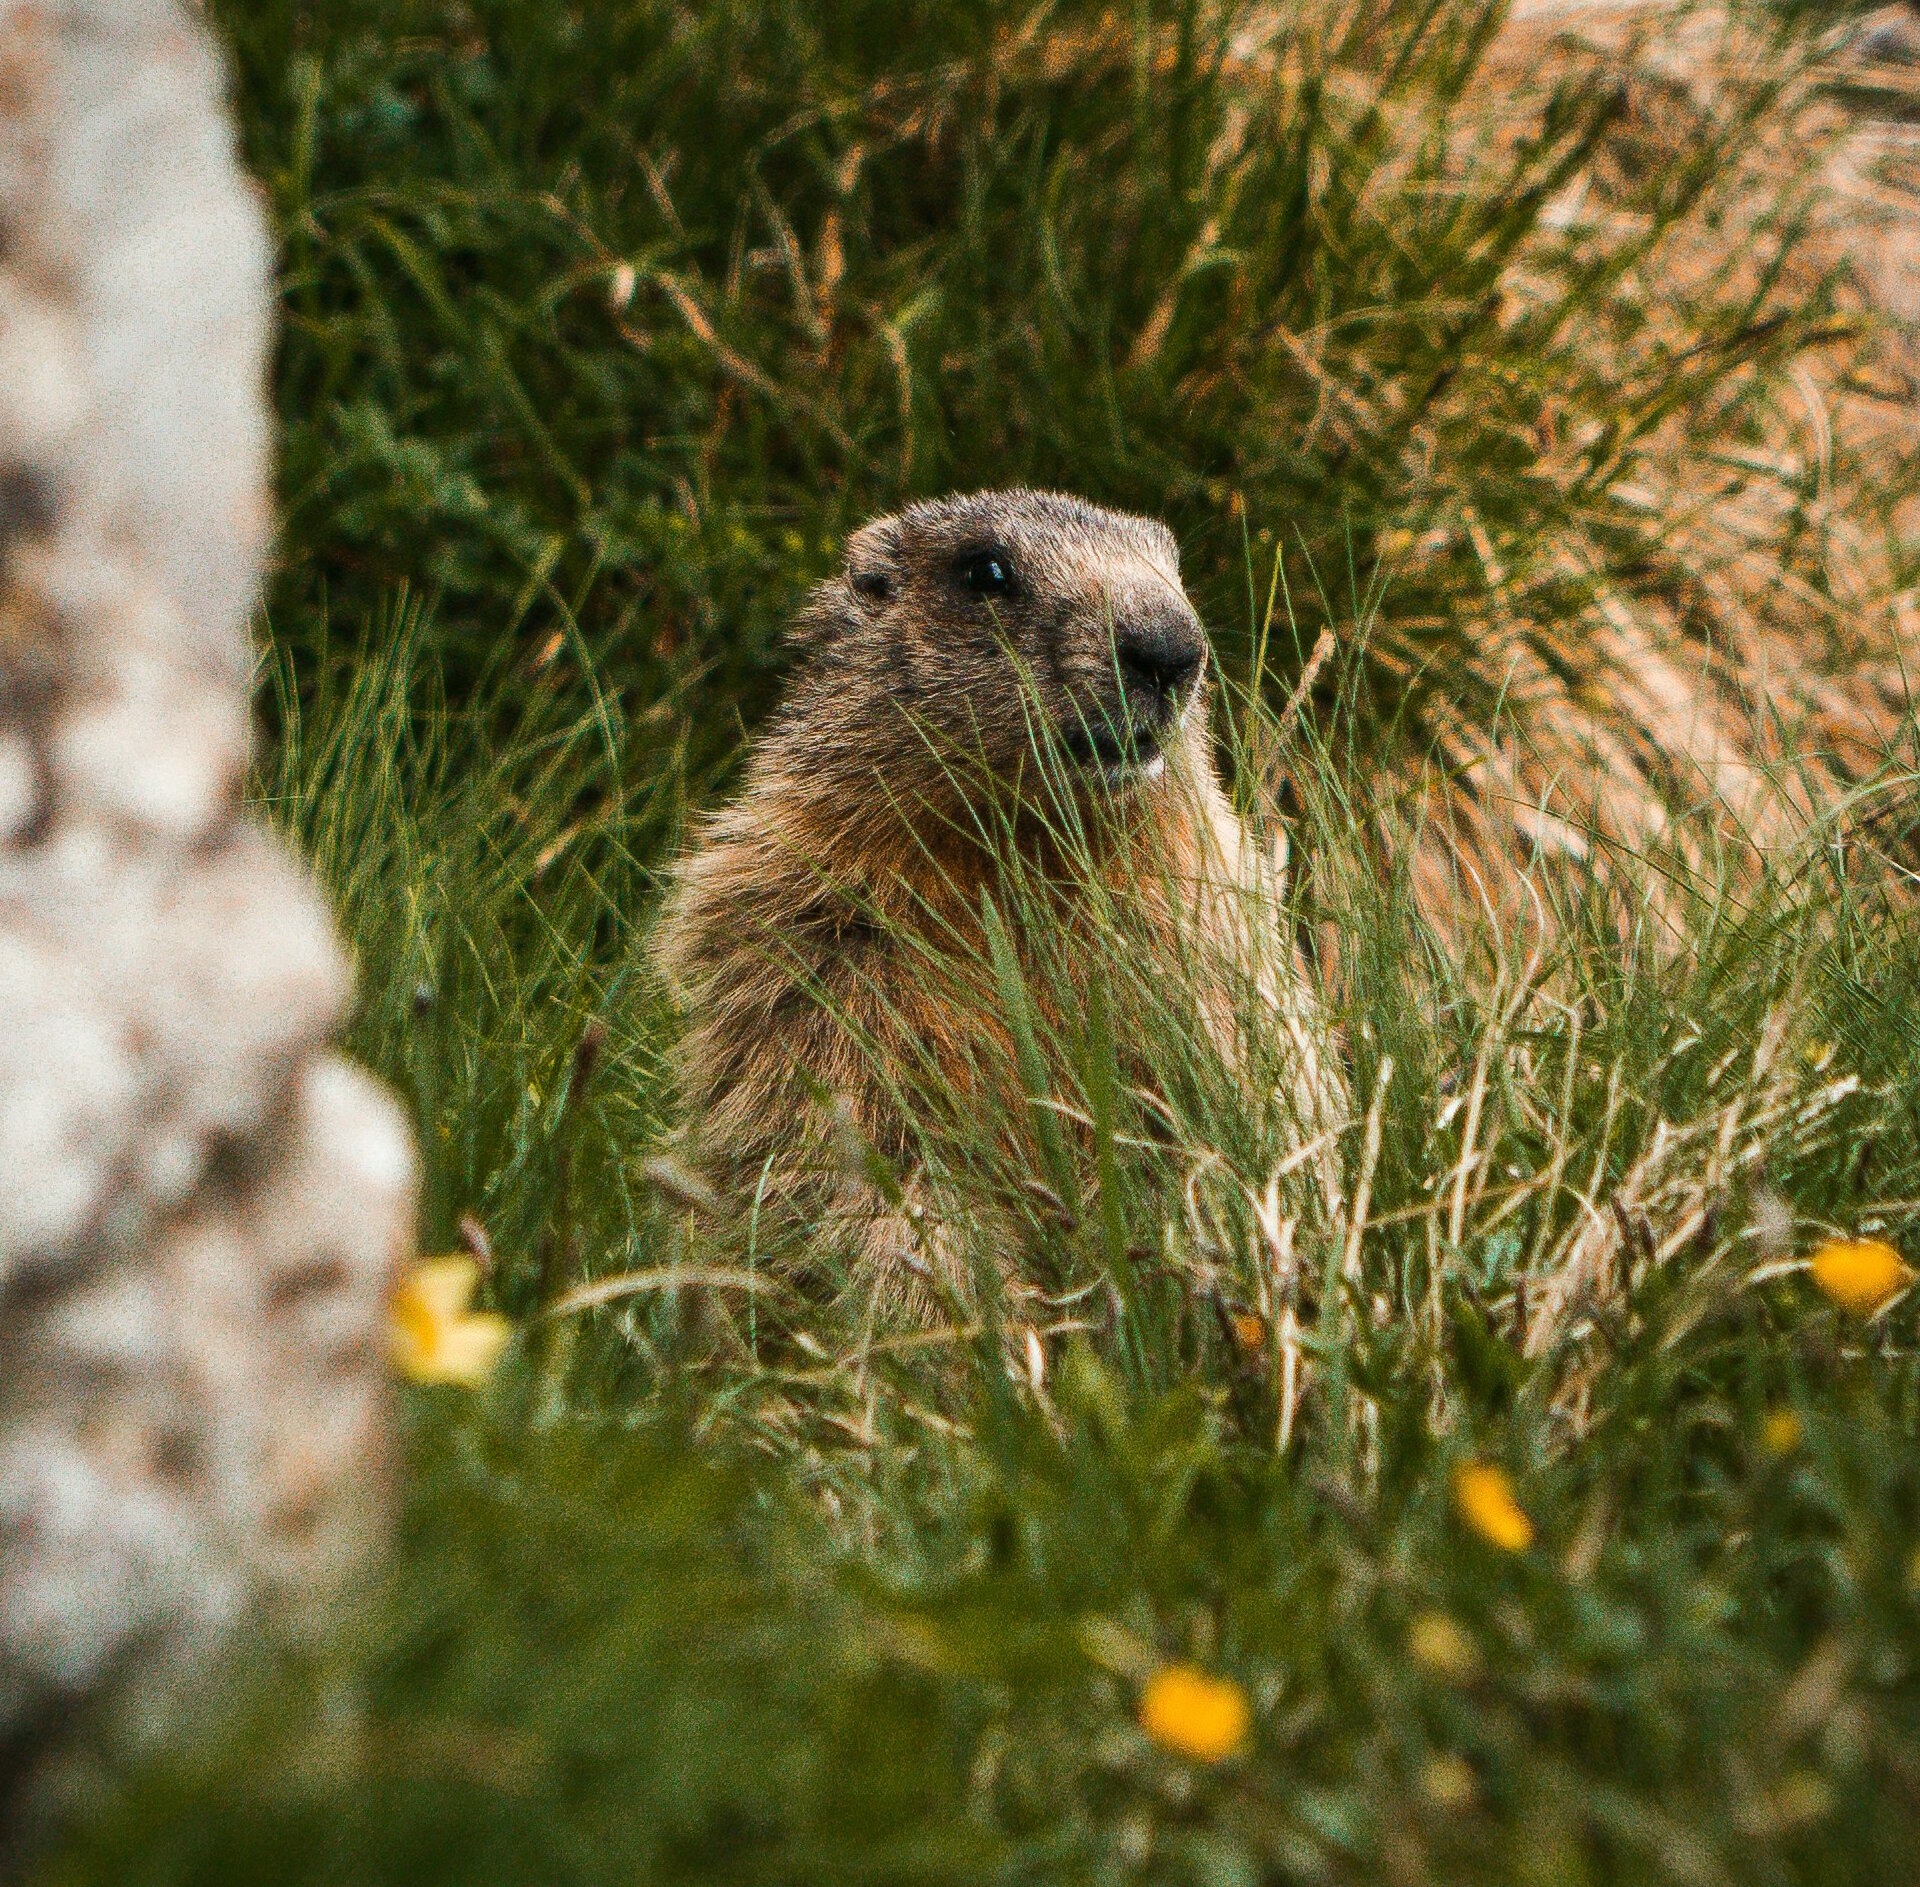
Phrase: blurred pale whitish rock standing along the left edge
[{"left": 0, "top": 0, "right": 413, "bottom": 1804}]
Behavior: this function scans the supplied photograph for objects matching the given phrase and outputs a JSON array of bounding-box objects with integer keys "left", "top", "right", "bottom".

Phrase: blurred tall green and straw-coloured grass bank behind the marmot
[{"left": 215, "top": 0, "right": 1910, "bottom": 837}]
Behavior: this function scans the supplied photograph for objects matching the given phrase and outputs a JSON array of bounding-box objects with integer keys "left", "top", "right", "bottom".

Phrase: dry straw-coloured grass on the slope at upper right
[{"left": 1305, "top": 6, "right": 1920, "bottom": 916}]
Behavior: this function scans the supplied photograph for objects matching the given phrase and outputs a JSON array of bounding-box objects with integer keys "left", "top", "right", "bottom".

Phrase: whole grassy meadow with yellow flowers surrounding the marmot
[{"left": 40, "top": 0, "right": 1920, "bottom": 1887}]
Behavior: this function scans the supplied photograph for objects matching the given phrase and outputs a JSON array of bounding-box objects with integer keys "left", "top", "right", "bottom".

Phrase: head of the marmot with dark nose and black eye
[{"left": 806, "top": 491, "right": 1208, "bottom": 785}]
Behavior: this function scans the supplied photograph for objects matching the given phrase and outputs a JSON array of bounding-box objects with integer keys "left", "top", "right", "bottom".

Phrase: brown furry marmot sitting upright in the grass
[{"left": 655, "top": 491, "right": 1336, "bottom": 1313}]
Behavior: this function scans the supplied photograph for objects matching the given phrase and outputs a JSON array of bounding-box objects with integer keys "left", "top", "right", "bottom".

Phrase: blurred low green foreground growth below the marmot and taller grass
[{"left": 50, "top": 1336, "right": 1920, "bottom": 1883}]
